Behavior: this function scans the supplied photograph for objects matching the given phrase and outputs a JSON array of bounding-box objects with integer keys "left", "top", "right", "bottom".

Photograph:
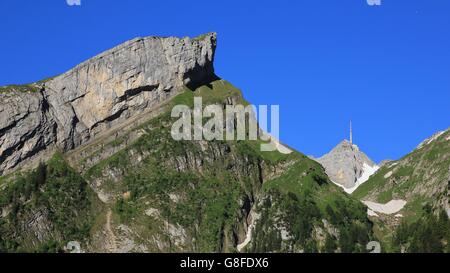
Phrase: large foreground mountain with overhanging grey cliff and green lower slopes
[{"left": 0, "top": 34, "right": 373, "bottom": 252}]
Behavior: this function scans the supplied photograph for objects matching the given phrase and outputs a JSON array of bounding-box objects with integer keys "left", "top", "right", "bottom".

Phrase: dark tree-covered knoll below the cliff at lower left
[{"left": 0, "top": 154, "right": 102, "bottom": 252}]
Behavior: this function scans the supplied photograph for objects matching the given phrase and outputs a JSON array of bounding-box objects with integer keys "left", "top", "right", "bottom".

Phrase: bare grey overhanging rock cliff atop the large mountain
[{"left": 0, "top": 33, "right": 216, "bottom": 174}]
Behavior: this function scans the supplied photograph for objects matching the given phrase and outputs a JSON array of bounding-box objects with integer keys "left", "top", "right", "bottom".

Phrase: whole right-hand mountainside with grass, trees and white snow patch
[{"left": 352, "top": 129, "right": 450, "bottom": 252}]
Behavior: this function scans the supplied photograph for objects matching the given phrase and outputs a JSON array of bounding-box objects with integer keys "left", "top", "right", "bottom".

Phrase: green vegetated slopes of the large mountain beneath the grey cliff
[{"left": 0, "top": 80, "right": 373, "bottom": 252}]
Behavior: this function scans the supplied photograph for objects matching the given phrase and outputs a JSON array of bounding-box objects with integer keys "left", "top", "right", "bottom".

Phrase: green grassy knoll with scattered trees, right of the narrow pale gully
[{"left": 253, "top": 157, "right": 372, "bottom": 252}]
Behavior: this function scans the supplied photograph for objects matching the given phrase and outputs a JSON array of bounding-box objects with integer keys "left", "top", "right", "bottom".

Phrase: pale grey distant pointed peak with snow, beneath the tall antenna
[{"left": 317, "top": 140, "right": 379, "bottom": 193}]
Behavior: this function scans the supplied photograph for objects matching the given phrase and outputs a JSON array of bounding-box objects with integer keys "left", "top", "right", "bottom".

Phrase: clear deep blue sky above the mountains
[{"left": 0, "top": 0, "right": 450, "bottom": 161}]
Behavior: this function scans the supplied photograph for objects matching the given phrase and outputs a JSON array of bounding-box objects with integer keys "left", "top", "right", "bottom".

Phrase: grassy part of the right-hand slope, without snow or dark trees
[{"left": 353, "top": 131, "right": 450, "bottom": 251}]
